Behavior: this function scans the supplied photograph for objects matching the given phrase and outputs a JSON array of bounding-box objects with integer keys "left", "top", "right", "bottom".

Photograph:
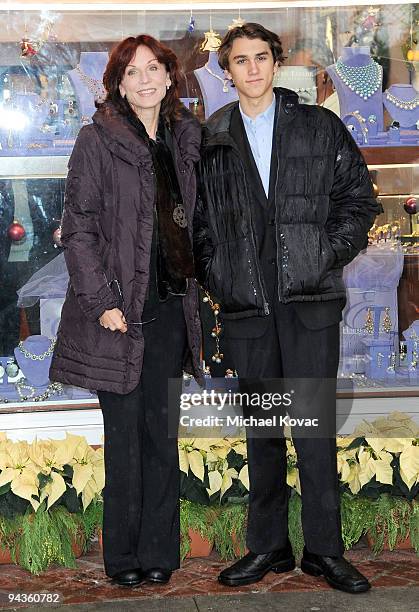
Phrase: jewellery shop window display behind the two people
[{"left": 0, "top": 2, "right": 419, "bottom": 404}]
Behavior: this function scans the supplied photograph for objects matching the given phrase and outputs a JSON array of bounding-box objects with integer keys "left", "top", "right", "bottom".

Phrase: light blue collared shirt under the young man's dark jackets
[{"left": 239, "top": 95, "right": 276, "bottom": 197}]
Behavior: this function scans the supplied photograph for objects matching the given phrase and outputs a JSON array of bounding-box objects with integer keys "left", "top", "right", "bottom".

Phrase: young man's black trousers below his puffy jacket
[{"left": 226, "top": 303, "right": 344, "bottom": 556}]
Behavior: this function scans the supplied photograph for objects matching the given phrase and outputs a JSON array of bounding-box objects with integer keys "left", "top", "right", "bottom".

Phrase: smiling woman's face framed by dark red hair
[{"left": 119, "top": 45, "right": 171, "bottom": 115}]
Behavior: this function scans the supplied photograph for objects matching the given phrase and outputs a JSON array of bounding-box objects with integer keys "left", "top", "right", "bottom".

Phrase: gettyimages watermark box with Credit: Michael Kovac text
[{"left": 169, "top": 378, "right": 342, "bottom": 438}]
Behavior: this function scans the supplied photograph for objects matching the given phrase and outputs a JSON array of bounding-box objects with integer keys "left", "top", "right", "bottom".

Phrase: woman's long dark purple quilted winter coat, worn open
[{"left": 50, "top": 102, "right": 202, "bottom": 394}]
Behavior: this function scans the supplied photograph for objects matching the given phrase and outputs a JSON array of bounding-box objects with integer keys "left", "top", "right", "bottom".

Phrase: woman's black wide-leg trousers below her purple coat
[{"left": 98, "top": 298, "right": 186, "bottom": 577}]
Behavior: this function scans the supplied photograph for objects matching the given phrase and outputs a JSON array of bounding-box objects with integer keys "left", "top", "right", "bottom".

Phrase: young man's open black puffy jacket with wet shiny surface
[{"left": 194, "top": 88, "right": 380, "bottom": 319}]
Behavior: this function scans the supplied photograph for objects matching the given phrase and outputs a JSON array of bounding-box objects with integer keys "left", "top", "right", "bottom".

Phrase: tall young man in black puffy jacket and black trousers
[{"left": 194, "top": 23, "right": 379, "bottom": 593}]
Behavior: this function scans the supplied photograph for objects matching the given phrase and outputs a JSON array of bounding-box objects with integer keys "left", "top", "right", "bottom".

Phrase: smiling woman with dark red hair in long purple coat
[{"left": 50, "top": 35, "right": 201, "bottom": 586}]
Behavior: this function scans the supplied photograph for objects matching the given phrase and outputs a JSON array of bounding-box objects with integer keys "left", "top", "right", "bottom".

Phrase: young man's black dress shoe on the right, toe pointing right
[{"left": 301, "top": 548, "right": 371, "bottom": 593}]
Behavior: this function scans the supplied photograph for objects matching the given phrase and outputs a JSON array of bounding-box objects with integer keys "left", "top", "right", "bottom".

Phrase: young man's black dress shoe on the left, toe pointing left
[{"left": 218, "top": 542, "right": 295, "bottom": 586}]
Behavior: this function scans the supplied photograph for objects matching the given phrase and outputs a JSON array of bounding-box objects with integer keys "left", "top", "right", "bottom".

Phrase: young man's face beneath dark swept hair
[{"left": 226, "top": 38, "right": 278, "bottom": 100}]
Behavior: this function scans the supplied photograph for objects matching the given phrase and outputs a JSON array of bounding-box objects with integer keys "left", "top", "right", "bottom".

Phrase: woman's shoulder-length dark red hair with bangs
[{"left": 103, "top": 34, "right": 182, "bottom": 121}]
